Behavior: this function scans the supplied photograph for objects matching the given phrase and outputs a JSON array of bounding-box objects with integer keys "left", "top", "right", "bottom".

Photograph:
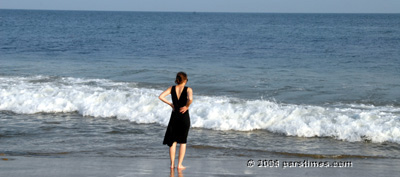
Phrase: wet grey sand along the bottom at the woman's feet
[{"left": 0, "top": 155, "right": 400, "bottom": 177}]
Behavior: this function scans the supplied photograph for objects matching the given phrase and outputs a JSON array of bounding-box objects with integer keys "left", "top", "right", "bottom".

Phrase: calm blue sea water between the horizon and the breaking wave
[{"left": 1, "top": 10, "right": 400, "bottom": 105}]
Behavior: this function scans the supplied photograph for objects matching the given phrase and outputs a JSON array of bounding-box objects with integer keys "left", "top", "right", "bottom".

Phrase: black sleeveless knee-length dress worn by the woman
[{"left": 163, "top": 86, "right": 190, "bottom": 146}]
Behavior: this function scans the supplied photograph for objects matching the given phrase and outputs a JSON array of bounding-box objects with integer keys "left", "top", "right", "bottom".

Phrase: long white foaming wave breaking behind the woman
[{"left": 0, "top": 76, "right": 400, "bottom": 143}]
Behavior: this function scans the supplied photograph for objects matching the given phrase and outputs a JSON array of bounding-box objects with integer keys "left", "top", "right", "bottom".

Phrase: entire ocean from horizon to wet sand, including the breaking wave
[{"left": 0, "top": 10, "right": 400, "bottom": 164}]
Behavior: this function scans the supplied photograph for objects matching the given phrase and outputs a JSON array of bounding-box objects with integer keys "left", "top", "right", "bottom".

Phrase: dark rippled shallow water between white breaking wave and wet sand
[{"left": 0, "top": 111, "right": 400, "bottom": 159}]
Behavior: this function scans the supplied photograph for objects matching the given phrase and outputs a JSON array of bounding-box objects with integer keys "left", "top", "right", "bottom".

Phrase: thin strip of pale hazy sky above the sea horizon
[{"left": 0, "top": 0, "right": 400, "bottom": 13}]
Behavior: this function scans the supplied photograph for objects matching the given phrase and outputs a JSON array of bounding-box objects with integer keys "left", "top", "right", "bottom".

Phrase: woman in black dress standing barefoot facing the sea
[{"left": 158, "top": 72, "right": 193, "bottom": 170}]
